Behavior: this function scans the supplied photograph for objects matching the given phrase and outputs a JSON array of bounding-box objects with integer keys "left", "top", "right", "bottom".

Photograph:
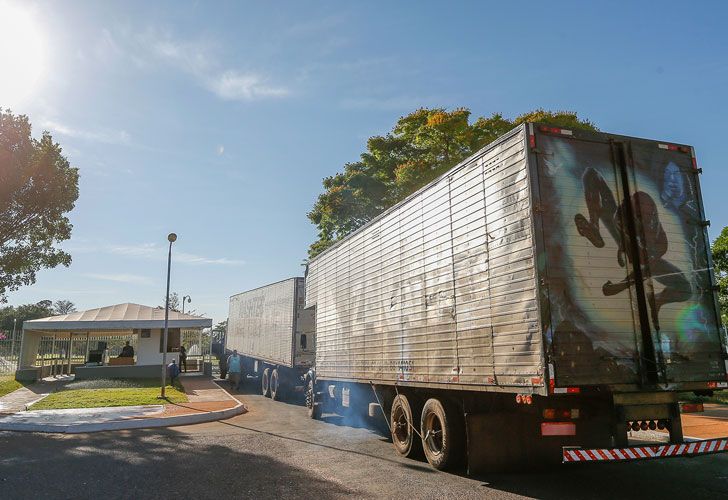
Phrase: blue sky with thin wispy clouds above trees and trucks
[{"left": 0, "top": 0, "right": 728, "bottom": 322}]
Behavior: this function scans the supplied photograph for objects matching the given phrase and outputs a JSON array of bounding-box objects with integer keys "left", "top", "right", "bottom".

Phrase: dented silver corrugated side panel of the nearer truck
[{"left": 307, "top": 128, "right": 543, "bottom": 386}]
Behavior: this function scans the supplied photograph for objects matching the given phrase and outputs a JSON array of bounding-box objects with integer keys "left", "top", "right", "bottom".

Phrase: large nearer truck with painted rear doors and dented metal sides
[{"left": 305, "top": 123, "right": 728, "bottom": 470}]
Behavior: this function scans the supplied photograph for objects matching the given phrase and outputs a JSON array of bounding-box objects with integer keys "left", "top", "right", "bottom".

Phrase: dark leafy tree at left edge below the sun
[{"left": 0, "top": 108, "right": 78, "bottom": 302}]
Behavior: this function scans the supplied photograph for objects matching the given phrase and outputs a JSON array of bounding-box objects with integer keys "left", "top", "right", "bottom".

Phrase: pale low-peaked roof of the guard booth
[{"left": 23, "top": 302, "right": 212, "bottom": 331}]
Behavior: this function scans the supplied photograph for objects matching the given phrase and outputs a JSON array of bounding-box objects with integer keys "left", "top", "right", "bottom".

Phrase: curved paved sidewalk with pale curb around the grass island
[{"left": 0, "top": 375, "right": 247, "bottom": 434}]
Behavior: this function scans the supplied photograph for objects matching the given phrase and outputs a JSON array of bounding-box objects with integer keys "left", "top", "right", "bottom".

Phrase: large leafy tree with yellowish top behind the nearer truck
[{"left": 308, "top": 108, "right": 597, "bottom": 257}]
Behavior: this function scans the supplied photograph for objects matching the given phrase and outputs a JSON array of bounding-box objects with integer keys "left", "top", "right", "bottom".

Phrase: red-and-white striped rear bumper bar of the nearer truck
[{"left": 562, "top": 437, "right": 728, "bottom": 463}]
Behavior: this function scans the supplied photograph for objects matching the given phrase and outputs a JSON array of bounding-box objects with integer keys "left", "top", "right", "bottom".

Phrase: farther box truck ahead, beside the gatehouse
[{"left": 226, "top": 277, "right": 315, "bottom": 400}]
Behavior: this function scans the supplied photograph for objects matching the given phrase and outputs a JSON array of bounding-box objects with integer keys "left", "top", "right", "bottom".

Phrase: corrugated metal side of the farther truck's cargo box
[{"left": 227, "top": 278, "right": 303, "bottom": 367}]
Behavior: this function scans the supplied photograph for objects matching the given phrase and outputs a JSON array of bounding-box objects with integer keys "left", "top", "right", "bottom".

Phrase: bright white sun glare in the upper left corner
[{"left": 0, "top": 2, "right": 44, "bottom": 108}]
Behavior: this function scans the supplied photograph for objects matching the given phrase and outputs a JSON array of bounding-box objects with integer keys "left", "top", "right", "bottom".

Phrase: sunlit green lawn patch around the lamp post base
[{"left": 30, "top": 379, "right": 187, "bottom": 410}]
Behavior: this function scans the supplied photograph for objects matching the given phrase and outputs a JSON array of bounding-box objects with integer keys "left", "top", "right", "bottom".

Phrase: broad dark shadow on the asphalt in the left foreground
[{"left": 0, "top": 429, "right": 356, "bottom": 499}]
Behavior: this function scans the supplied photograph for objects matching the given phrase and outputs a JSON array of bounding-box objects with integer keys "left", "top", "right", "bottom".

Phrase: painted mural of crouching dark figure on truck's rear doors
[{"left": 538, "top": 132, "right": 724, "bottom": 385}]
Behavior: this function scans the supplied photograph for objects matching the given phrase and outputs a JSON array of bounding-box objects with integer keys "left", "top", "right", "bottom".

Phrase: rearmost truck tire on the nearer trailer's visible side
[{"left": 420, "top": 398, "right": 465, "bottom": 470}]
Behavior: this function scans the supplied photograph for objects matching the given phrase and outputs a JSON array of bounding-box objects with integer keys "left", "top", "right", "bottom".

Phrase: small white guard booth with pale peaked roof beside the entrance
[{"left": 15, "top": 303, "right": 212, "bottom": 382}]
